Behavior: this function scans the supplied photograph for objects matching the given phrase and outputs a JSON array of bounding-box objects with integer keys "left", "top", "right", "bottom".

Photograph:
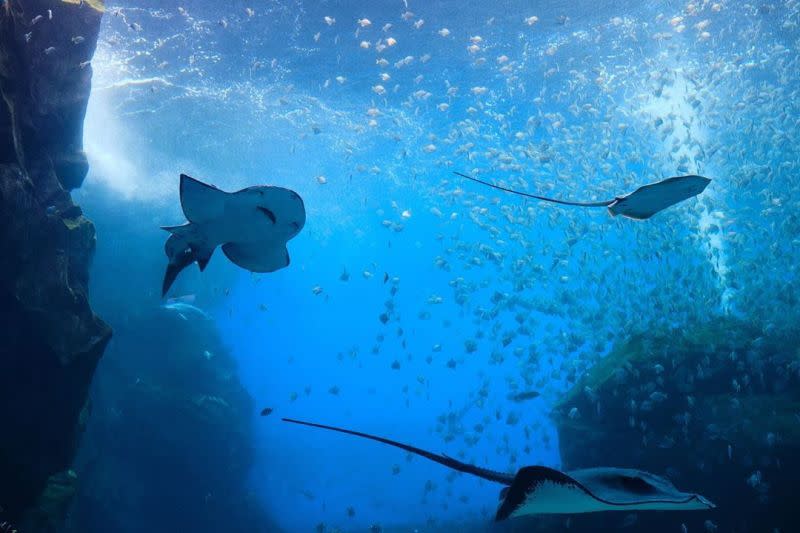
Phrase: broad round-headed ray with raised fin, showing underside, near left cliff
[{"left": 162, "top": 174, "right": 306, "bottom": 295}]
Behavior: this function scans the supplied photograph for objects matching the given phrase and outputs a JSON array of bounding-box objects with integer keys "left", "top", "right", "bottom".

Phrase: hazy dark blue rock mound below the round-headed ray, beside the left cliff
[{"left": 67, "top": 307, "right": 278, "bottom": 533}]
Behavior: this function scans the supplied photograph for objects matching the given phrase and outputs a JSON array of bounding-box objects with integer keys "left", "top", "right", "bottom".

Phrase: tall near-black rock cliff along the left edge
[{"left": 0, "top": 0, "right": 111, "bottom": 531}]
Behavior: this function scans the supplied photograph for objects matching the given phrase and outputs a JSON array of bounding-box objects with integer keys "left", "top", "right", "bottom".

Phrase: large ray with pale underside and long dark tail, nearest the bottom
[{"left": 282, "top": 418, "right": 715, "bottom": 521}]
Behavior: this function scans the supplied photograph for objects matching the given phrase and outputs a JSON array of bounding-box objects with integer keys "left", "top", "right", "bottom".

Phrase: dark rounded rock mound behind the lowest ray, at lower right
[{"left": 555, "top": 320, "right": 800, "bottom": 532}]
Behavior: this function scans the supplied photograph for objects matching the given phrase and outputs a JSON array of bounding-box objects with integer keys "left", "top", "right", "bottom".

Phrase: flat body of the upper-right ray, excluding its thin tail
[{"left": 608, "top": 175, "right": 711, "bottom": 220}]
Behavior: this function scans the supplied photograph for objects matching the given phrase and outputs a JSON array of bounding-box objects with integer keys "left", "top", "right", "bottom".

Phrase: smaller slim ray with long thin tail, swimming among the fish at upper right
[{"left": 455, "top": 172, "right": 711, "bottom": 220}]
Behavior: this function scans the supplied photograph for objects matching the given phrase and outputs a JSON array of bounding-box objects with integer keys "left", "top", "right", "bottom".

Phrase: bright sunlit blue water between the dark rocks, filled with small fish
[{"left": 70, "top": 0, "right": 798, "bottom": 531}]
